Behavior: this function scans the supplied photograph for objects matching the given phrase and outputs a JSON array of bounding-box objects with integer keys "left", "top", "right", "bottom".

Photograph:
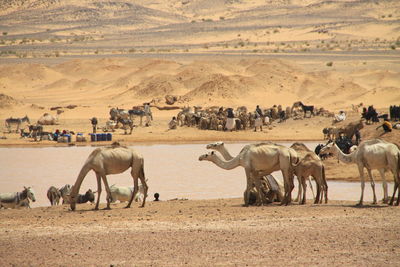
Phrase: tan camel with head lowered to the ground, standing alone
[{"left": 70, "top": 142, "right": 148, "bottom": 210}]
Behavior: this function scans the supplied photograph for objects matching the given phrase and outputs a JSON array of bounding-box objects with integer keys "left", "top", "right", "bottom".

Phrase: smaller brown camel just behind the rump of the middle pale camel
[{"left": 290, "top": 143, "right": 328, "bottom": 204}]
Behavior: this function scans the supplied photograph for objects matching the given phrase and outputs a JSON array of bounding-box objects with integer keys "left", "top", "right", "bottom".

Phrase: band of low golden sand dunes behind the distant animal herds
[{"left": 0, "top": 59, "right": 400, "bottom": 112}]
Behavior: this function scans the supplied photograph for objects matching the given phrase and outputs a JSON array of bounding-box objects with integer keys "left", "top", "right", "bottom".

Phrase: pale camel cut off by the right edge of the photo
[{"left": 321, "top": 139, "right": 400, "bottom": 206}]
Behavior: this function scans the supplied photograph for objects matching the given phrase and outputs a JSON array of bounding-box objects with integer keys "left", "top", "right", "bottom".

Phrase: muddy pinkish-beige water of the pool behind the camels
[{"left": 0, "top": 142, "right": 392, "bottom": 207}]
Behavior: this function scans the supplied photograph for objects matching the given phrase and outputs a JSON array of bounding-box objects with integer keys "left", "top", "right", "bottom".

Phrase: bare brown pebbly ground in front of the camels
[{"left": 0, "top": 199, "right": 400, "bottom": 266}]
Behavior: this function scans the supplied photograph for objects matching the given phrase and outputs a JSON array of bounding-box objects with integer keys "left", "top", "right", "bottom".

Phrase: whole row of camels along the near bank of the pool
[{"left": 70, "top": 139, "right": 400, "bottom": 213}]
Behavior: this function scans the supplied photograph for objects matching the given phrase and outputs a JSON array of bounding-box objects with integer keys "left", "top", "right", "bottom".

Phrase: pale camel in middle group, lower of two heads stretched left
[{"left": 199, "top": 143, "right": 297, "bottom": 206}]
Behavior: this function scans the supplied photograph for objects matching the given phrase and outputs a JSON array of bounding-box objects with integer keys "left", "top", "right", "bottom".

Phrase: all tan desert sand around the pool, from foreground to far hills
[{"left": 0, "top": 0, "right": 400, "bottom": 266}]
